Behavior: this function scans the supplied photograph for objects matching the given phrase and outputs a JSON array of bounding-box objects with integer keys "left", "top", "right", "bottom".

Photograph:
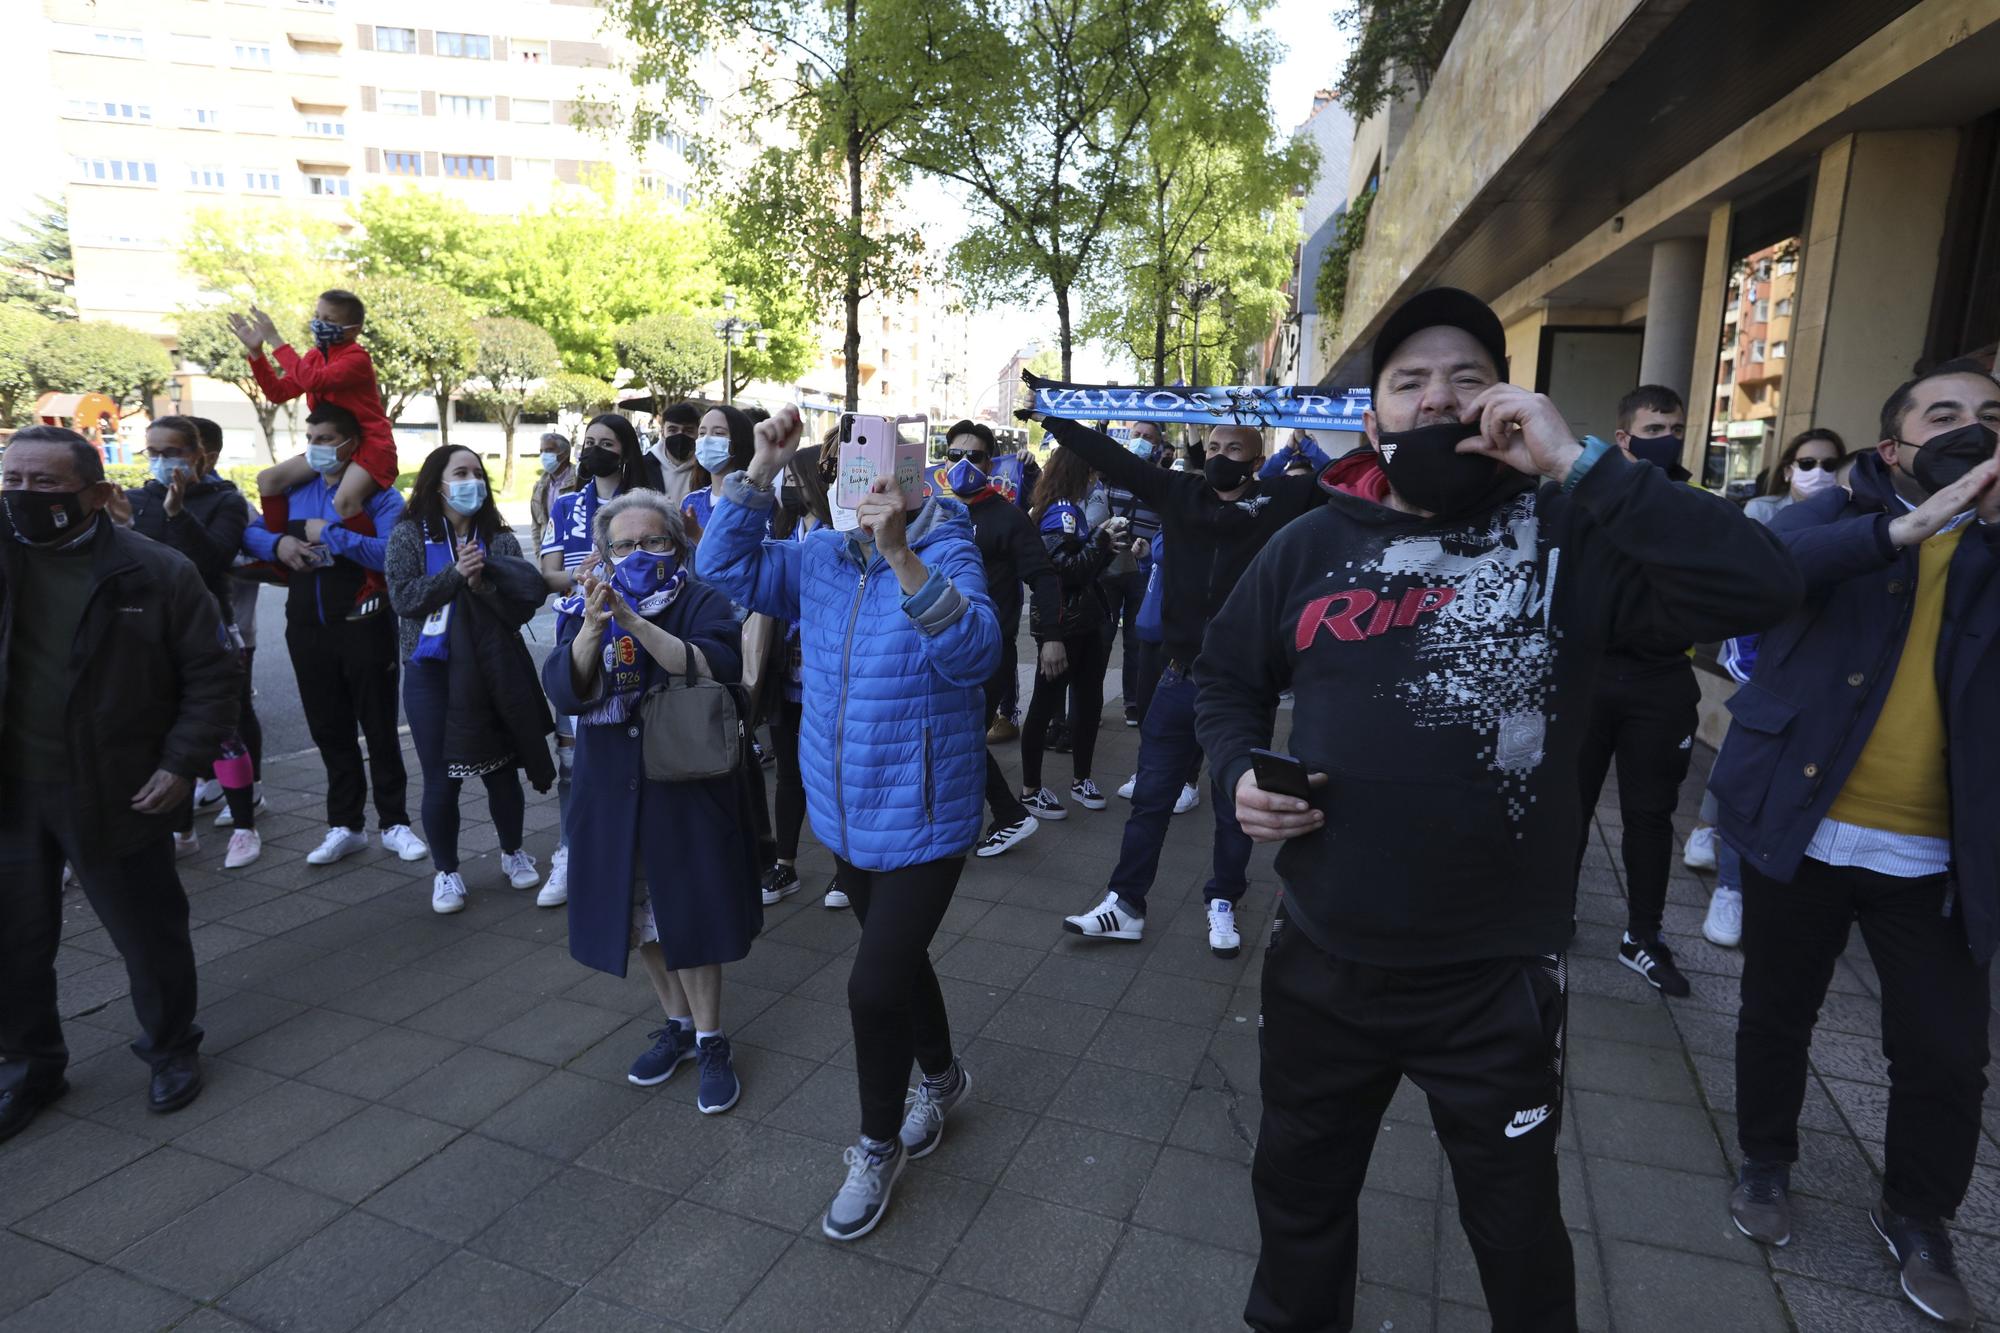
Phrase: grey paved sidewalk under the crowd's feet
[{"left": 0, "top": 705, "right": 2000, "bottom": 1333}]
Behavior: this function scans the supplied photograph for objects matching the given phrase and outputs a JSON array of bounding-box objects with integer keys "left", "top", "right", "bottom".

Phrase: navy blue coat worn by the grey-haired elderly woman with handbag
[{"left": 542, "top": 578, "right": 764, "bottom": 977}]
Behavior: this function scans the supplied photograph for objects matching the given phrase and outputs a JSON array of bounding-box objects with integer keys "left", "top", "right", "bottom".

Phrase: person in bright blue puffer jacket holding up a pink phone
[{"left": 696, "top": 408, "right": 1000, "bottom": 1241}]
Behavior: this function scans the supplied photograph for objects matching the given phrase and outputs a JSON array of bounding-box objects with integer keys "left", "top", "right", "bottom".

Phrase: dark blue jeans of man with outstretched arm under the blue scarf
[{"left": 1110, "top": 664, "right": 1250, "bottom": 917}]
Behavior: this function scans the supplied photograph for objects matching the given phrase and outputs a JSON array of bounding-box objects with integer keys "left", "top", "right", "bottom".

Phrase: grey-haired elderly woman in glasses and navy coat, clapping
[{"left": 542, "top": 490, "right": 762, "bottom": 1115}]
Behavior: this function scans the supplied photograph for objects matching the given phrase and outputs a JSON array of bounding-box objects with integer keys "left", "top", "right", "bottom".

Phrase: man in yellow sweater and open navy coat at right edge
[{"left": 1710, "top": 360, "right": 2000, "bottom": 1327}]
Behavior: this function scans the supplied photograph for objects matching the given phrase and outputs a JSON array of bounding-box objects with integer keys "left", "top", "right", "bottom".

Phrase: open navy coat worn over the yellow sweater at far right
[{"left": 1708, "top": 454, "right": 2000, "bottom": 963}]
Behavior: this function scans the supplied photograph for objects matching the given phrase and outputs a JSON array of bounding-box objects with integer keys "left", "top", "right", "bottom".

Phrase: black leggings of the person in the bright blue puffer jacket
[{"left": 834, "top": 857, "right": 966, "bottom": 1141}]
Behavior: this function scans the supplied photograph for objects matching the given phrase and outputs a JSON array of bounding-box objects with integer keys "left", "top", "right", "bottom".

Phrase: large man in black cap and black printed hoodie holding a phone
[{"left": 1168, "top": 288, "right": 1802, "bottom": 1333}]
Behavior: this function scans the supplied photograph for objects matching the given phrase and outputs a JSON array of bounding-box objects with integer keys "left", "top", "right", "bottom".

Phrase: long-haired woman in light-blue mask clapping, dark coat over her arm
[{"left": 384, "top": 444, "right": 556, "bottom": 915}]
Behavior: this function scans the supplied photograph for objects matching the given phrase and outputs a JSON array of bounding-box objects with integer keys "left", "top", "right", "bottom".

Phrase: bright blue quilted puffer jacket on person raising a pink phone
[{"left": 694, "top": 472, "right": 1000, "bottom": 871}]
